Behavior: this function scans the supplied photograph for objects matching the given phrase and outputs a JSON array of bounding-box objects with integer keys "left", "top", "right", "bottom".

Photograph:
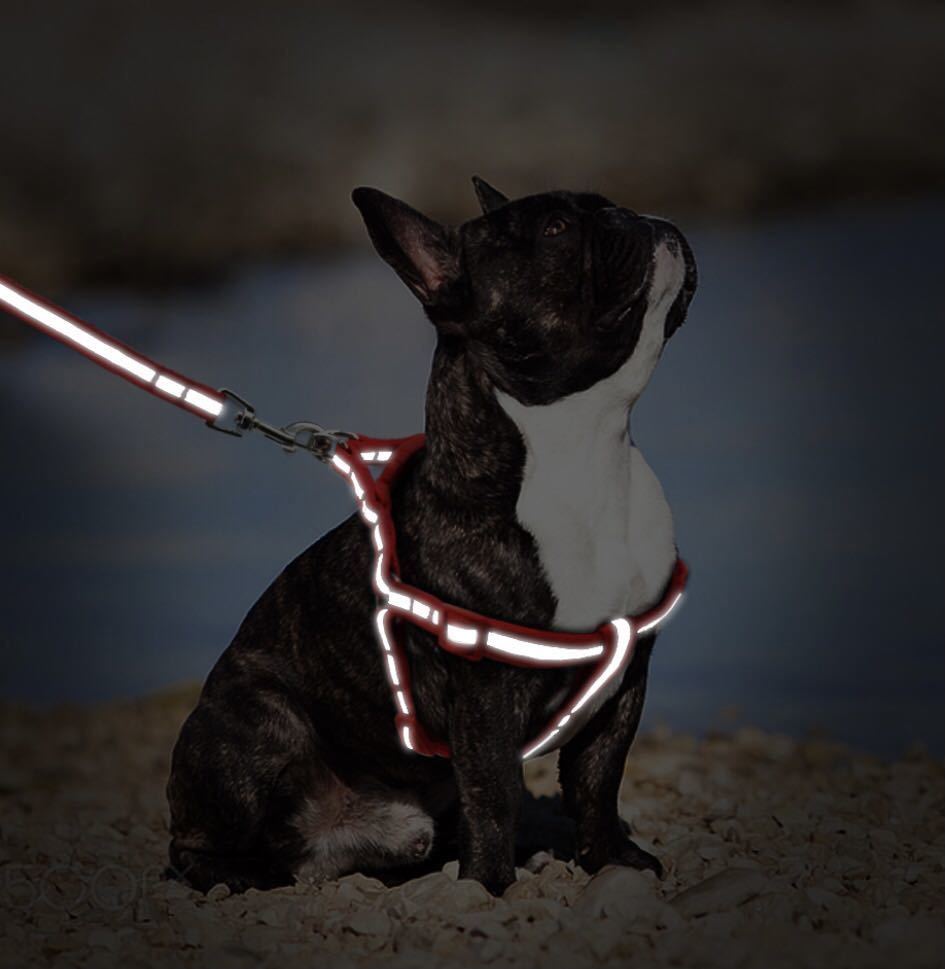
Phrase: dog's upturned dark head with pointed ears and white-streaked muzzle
[{"left": 352, "top": 178, "right": 696, "bottom": 405}]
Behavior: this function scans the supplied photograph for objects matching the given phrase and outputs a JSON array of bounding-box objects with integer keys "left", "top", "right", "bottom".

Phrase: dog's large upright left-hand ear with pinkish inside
[{"left": 351, "top": 188, "right": 459, "bottom": 306}]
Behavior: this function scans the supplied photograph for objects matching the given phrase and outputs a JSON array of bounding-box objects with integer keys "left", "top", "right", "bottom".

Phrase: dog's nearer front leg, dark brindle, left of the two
[{"left": 450, "top": 692, "right": 524, "bottom": 895}]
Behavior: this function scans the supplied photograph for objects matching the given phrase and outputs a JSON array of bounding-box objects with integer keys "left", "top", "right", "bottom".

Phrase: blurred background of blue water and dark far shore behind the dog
[{"left": 0, "top": 0, "right": 945, "bottom": 754}]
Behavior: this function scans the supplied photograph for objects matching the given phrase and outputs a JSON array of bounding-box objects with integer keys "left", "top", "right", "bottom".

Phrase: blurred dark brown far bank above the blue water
[{"left": 0, "top": 0, "right": 945, "bottom": 288}]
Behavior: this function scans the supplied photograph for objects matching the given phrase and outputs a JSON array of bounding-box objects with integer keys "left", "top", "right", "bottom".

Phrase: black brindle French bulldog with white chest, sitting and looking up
[{"left": 168, "top": 179, "right": 695, "bottom": 893}]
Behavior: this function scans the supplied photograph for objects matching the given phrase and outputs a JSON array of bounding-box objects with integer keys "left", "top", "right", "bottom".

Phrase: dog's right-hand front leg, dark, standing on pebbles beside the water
[{"left": 558, "top": 640, "right": 663, "bottom": 877}]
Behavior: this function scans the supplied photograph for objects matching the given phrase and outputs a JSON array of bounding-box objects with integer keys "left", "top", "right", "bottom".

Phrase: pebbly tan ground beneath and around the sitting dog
[{"left": 0, "top": 689, "right": 945, "bottom": 969}]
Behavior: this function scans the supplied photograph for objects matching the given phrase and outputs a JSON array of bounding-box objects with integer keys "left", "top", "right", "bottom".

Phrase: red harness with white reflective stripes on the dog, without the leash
[{"left": 331, "top": 434, "right": 688, "bottom": 760}]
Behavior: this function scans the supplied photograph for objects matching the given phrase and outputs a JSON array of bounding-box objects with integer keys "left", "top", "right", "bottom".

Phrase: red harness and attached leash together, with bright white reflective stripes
[{"left": 0, "top": 277, "right": 689, "bottom": 760}]
